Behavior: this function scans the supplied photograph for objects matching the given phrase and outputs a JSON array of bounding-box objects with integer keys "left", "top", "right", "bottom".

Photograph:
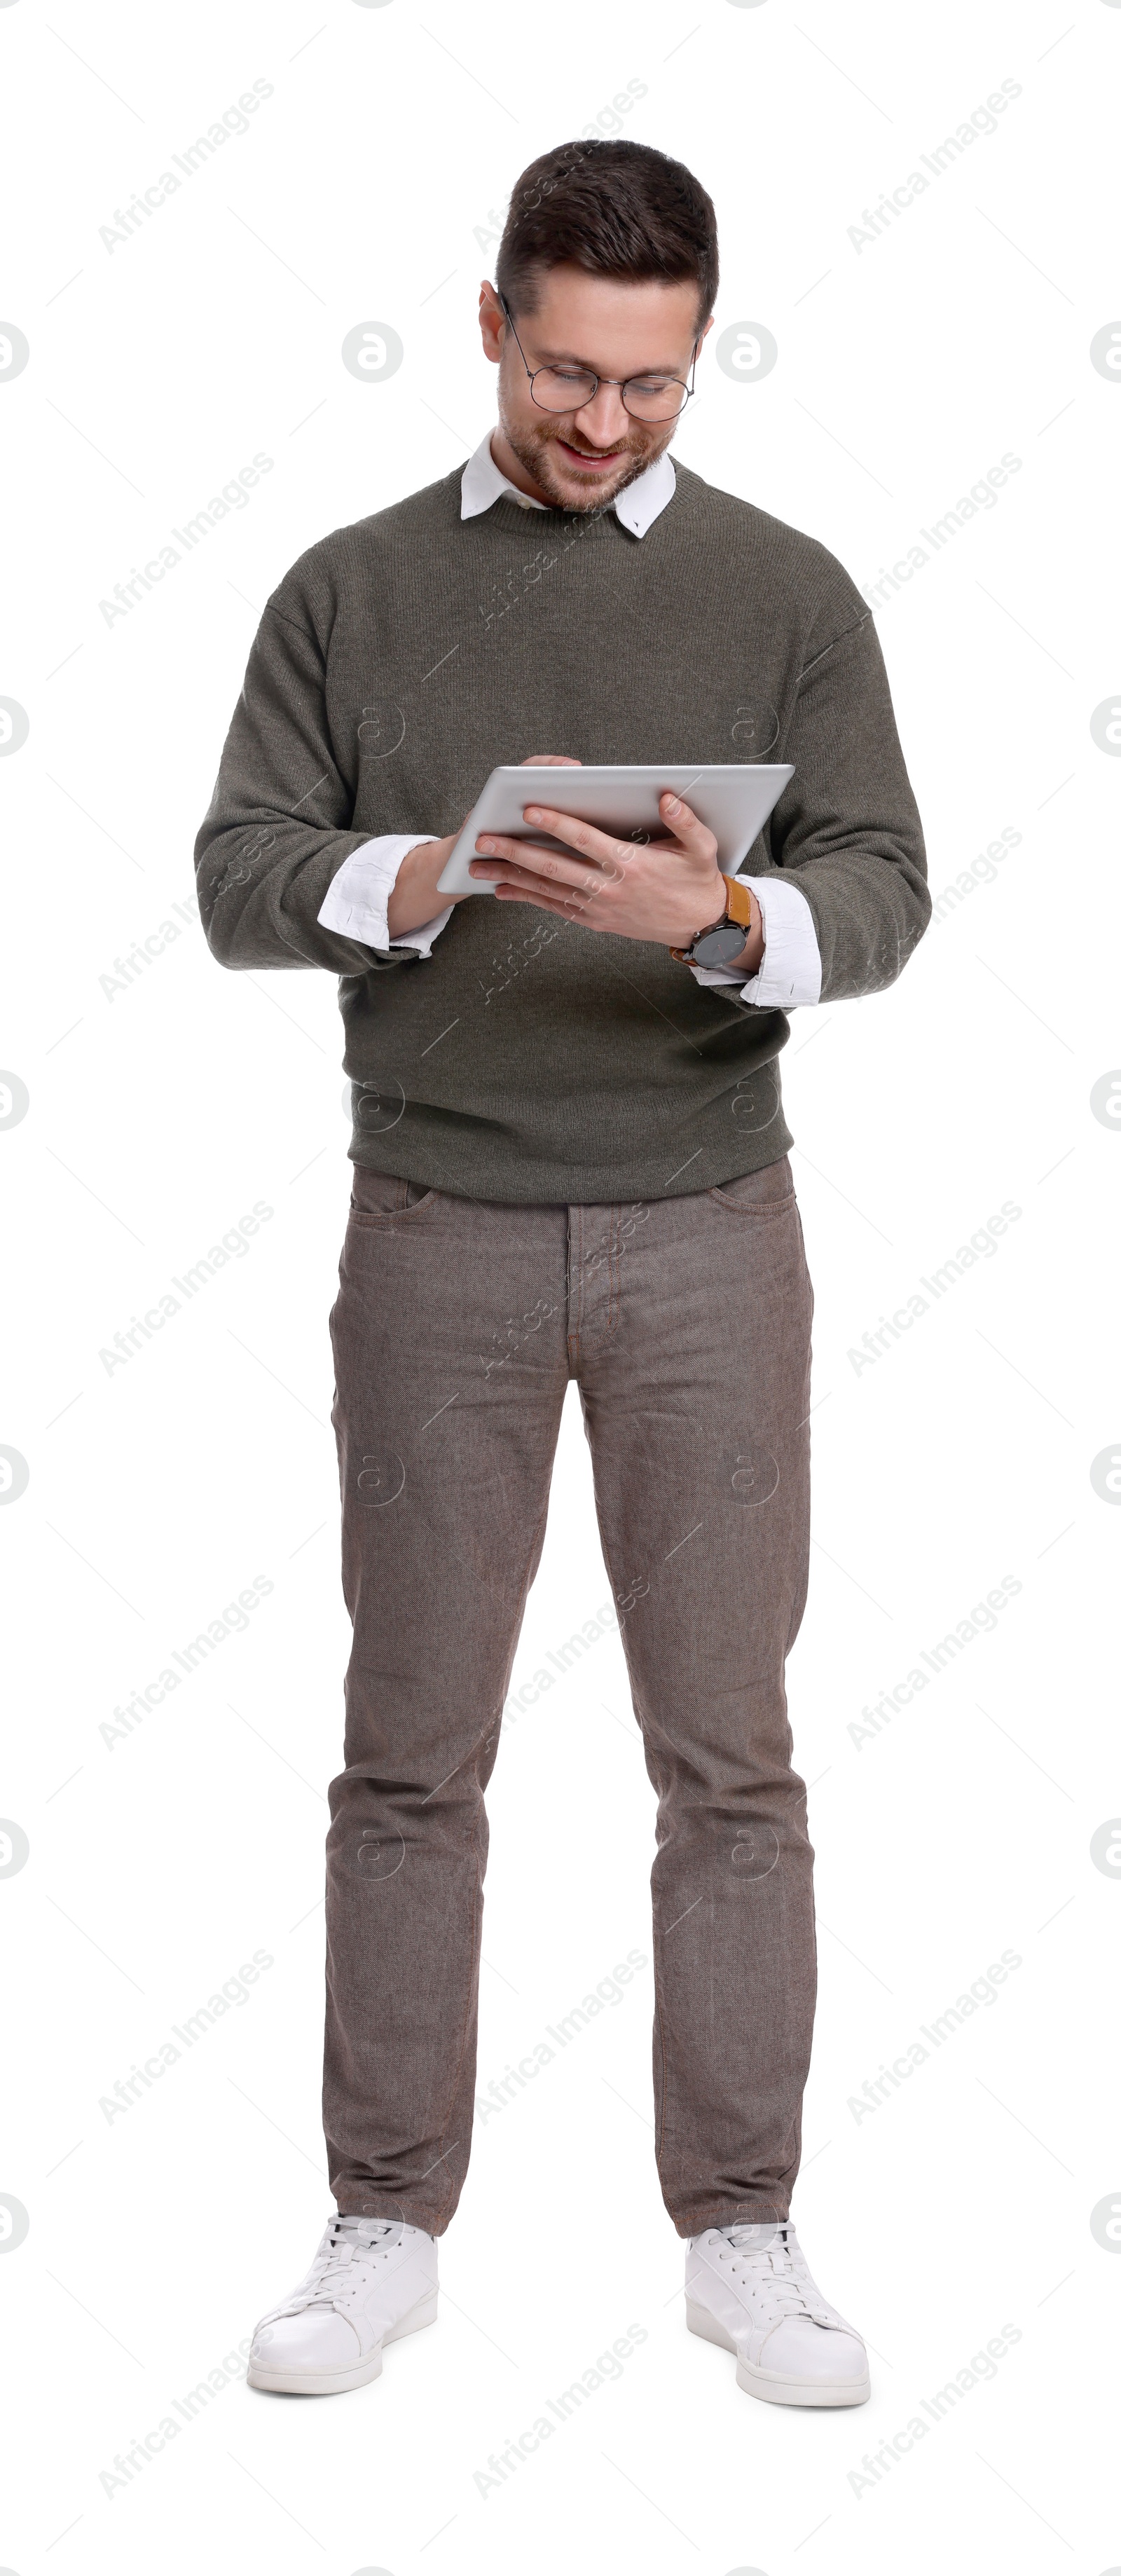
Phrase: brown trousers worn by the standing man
[{"left": 324, "top": 1154, "right": 817, "bottom": 2236}]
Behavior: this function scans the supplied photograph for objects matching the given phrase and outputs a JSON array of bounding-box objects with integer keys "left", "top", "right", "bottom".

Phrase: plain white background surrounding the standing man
[{"left": 0, "top": 0, "right": 1121, "bottom": 2576}]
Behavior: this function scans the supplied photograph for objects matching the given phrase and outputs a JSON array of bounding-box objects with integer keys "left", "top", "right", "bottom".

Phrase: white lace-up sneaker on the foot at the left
[{"left": 247, "top": 2215, "right": 436, "bottom": 2398}]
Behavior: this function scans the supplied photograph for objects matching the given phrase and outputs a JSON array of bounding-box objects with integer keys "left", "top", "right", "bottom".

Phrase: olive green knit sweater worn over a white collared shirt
[{"left": 196, "top": 464, "right": 930, "bottom": 1203}]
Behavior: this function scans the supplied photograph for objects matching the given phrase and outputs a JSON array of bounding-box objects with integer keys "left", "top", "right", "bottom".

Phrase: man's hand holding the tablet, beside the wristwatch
[{"left": 472, "top": 788, "right": 757, "bottom": 964}]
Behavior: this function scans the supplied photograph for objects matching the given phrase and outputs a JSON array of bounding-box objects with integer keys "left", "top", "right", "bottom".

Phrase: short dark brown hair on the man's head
[{"left": 495, "top": 137, "right": 719, "bottom": 332}]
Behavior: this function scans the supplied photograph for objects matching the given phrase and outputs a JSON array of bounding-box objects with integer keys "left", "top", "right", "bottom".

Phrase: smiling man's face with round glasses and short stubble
[{"left": 479, "top": 268, "right": 711, "bottom": 510}]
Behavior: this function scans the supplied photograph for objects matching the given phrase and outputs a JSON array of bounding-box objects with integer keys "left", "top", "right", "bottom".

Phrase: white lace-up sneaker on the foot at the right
[{"left": 685, "top": 2218, "right": 871, "bottom": 2406}]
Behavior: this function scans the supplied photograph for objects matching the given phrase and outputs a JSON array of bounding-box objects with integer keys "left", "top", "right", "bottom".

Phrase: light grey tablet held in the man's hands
[{"left": 438, "top": 760, "right": 794, "bottom": 894}]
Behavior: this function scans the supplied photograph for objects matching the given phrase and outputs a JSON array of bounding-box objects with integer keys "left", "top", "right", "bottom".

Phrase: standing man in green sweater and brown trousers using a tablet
[{"left": 196, "top": 142, "right": 930, "bottom": 2406}]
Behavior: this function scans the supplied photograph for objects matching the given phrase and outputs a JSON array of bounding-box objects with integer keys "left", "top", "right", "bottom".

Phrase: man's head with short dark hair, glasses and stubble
[{"left": 479, "top": 142, "right": 719, "bottom": 510}]
